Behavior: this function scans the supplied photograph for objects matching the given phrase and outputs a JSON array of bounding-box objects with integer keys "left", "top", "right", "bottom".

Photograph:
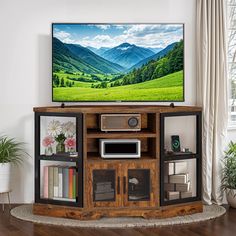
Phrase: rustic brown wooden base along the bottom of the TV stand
[{"left": 33, "top": 201, "right": 202, "bottom": 220}]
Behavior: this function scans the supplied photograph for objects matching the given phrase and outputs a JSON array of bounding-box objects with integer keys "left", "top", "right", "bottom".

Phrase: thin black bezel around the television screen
[{"left": 51, "top": 22, "right": 185, "bottom": 104}]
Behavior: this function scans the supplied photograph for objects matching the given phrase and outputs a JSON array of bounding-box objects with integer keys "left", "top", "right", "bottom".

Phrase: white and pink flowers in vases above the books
[{"left": 42, "top": 120, "right": 76, "bottom": 153}]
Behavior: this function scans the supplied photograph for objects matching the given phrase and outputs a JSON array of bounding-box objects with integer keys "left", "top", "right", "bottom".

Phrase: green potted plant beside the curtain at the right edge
[{"left": 222, "top": 141, "right": 236, "bottom": 208}]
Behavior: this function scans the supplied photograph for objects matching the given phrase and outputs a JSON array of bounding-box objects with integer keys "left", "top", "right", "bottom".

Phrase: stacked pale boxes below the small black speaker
[{"left": 164, "top": 161, "right": 192, "bottom": 200}]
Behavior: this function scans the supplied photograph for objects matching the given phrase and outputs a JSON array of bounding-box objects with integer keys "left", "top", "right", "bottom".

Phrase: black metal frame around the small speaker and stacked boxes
[{"left": 160, "top": 111, "right": 202, "bottom": 206}]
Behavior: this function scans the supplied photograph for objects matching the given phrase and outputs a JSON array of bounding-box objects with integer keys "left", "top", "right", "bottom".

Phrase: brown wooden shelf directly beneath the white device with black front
[{"left": 87, "top": 152, "right": 155, "bottom": 162}]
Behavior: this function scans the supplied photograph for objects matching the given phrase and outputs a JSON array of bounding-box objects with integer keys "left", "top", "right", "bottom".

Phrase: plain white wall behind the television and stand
[{"left": 0, "top": 0, "right": 196, "bottom": 202}]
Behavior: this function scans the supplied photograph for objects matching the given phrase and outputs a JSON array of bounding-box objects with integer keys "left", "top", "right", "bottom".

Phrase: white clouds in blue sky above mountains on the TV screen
[{"left": 54, "top": 24, "right": 183, "bottom": 48}]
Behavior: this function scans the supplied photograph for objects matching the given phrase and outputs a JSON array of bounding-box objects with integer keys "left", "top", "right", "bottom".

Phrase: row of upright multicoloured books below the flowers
[{"left": 43, "top": 166, "right": 76, "bottom": 202}]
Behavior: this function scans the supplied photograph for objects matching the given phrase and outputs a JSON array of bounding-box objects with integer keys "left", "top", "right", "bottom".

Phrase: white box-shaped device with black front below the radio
[{"left": 99, "top": 139, "right": 141, "bottom": 158}]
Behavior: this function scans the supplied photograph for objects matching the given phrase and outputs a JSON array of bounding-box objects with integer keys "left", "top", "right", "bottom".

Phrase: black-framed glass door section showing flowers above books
[{"left": 35, "top": 112, "right": 83, "bottom": 207}]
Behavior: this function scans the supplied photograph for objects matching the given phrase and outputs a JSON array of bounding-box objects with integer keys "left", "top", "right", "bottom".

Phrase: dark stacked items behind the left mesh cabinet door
[{"left": 94, "top": 181, "right": 115, "bottom": 201}]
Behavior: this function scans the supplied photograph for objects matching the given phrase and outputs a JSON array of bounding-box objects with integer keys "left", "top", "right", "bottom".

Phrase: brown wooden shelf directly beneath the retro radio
[{"left": 87, "top": 129, "right": 156, "bottom": 138}]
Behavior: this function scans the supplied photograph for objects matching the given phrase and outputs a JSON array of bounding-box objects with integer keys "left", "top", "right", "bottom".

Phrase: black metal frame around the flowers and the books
[{"left": 35, "top": 112, "right": 83, "bottom": 207}]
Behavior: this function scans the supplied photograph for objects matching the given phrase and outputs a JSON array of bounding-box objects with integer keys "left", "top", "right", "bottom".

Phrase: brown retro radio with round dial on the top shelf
[{"left": 100, "top": 114, "right": 141, "bottom": 131}]
